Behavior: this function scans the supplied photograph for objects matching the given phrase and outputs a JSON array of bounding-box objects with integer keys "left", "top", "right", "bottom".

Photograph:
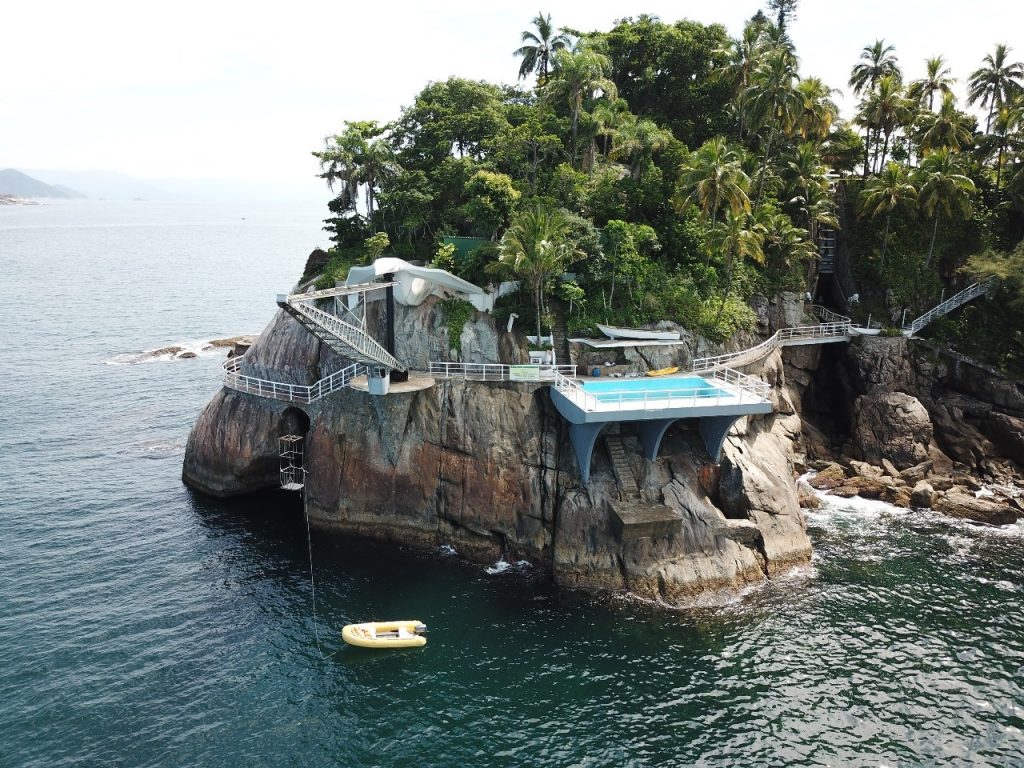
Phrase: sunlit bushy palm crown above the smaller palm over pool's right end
[{"left": 675, "top": 136, "right": 751, "bottom": 227}]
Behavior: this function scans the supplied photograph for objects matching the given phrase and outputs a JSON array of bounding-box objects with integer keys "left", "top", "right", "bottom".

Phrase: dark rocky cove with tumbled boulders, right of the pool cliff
[{"left": 804, "top": 337, "right": 1024, "bottom": 524}]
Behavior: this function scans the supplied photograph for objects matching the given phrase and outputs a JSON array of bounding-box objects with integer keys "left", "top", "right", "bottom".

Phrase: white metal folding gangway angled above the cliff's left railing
[{"left": 278, "top": 283, "right": 406, "bottom": 371}]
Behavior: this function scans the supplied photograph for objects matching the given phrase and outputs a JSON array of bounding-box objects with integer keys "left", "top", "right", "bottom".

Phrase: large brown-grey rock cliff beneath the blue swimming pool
[{"left": 183, "top": 290, "right": 814, "bottom": 604}]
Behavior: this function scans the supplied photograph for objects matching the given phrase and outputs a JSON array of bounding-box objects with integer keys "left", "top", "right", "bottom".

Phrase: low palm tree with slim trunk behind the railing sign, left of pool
[{"left": 488, "top": 203, "right": 585, "bottom": 339}]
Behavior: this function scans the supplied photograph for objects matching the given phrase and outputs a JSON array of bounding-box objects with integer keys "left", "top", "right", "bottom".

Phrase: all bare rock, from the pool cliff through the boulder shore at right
[{"left": 182, "top": 288, "right": 1024, "bottom": 605}]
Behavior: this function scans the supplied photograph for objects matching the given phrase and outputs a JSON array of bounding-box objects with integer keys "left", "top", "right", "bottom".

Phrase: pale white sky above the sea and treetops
[{"left": 0, "top": 0, "right": 1024, "bottom": 195}]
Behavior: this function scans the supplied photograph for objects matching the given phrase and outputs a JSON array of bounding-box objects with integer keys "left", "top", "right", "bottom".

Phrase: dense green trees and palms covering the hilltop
[{"left": 315, "top": 8, "right": 1024, "bottom": 364}]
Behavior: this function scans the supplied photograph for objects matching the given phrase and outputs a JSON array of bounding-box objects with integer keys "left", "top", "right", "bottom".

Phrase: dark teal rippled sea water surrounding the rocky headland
[{"left": 0, "top": 202, "right": 1024, "bottom": 768}]
